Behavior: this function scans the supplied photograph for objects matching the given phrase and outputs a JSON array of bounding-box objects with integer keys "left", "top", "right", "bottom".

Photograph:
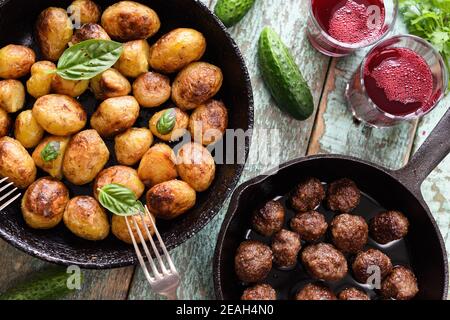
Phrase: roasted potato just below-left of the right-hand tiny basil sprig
[{"left": 114, "top": 128, "right": 153, "bottom": 166}]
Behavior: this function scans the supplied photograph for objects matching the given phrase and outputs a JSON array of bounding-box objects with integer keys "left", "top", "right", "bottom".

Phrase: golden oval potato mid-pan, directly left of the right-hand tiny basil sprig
[{"left": 91, "top": 96, "right": 139, "bottom": 137}]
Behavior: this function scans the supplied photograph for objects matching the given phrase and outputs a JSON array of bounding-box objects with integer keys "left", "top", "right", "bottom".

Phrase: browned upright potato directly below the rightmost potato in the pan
[{"left": 177, "top": 143, "right": 216, "bottom": 192}]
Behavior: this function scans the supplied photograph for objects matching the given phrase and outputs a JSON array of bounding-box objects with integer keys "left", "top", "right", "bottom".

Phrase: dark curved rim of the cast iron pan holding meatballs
[{"left": 213, "top": 154, "right": 449, "bottom": 300}]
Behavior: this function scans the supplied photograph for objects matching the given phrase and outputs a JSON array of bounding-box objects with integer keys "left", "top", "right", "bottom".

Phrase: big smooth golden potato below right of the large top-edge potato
[{"left": 150, "top": 28, "right": 206, "bottom": 73}]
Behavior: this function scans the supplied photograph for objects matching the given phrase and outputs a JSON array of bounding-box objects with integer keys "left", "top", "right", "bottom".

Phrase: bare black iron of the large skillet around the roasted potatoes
[{"left": 0, "top": 0, "right": 253, "bottom": 268}]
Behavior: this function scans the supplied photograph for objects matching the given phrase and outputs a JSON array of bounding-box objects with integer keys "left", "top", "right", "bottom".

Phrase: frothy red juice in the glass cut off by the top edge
[{"left": 312, "top": 0, "right": 385, "bottom": 44}]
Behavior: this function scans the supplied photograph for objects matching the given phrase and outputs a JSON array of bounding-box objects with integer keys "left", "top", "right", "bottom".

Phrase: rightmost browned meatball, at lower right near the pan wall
[{"left": 381, "top": 266, "right": 419, "bottom": 300}]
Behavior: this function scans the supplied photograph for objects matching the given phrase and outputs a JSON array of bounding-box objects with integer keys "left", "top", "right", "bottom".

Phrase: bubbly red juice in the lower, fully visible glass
[{"left": 364, "top": 48, "right": 441, "bottom": 116}]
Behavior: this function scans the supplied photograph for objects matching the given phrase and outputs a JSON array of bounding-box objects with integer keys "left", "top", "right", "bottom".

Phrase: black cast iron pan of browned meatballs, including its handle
[{"left": 214, "top": 107, "right": 450, "bottom": 300}]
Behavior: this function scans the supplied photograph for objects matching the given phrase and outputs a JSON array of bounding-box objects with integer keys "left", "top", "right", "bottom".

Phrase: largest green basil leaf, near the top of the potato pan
[{"left": 56, "top": 39, "right": 123, "bottom": 80}]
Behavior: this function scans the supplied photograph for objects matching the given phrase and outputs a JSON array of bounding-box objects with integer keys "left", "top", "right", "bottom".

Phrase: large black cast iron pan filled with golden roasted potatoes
[{"left": 0, "top": 0, "right": 253, "bottom": 268}]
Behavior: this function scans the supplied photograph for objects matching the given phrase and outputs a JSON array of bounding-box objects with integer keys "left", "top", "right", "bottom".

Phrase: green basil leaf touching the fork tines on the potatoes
[{"left": 98, "top": 183, "right": 145, "bottom": 217}]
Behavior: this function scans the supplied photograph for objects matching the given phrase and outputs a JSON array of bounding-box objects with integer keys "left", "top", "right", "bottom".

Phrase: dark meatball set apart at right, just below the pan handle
[{"left": 370, "top": 211, "right": 409, "bottom": 244}]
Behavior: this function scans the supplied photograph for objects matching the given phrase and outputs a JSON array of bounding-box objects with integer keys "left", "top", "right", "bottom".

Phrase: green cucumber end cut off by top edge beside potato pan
[{"left": 214, "top": 0, "right": 255, "bottom": 27}]
